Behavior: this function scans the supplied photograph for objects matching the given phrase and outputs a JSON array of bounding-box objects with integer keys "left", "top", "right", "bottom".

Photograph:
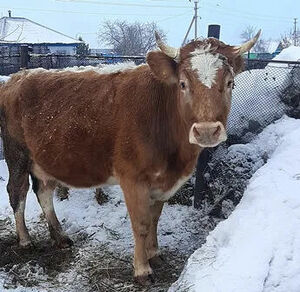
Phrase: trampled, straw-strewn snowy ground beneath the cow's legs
[{"left": 0, "top": 165, "right": 207, "bottom": 292}]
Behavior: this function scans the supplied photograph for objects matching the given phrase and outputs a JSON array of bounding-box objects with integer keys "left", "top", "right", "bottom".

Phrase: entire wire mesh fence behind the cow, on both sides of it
[{"left": 0, "top": 54, "right": 300, "bottom": 213}]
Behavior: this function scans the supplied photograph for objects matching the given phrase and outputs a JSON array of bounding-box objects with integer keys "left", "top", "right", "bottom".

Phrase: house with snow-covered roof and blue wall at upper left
[{"left": 0, "top": 12, "right": 82, "bottom": 55}]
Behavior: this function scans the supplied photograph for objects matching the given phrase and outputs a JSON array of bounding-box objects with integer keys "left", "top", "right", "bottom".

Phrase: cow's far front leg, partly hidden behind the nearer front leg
[{"left": 146, "top": 201, "right": 164, "bottom": 266}]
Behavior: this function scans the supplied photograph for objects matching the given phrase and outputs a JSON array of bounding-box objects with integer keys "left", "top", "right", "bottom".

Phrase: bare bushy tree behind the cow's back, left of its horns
[{"left": 99, "top": 20, "right": 166, "bottom": 55}]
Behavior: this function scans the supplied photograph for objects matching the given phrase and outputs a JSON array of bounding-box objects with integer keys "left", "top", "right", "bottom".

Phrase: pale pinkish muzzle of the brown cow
[{"left": 189, "top": 122, "right": 227, "bottom": 147}]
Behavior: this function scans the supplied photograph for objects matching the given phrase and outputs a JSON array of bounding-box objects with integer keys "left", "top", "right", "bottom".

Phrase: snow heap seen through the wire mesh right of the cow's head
[{"left": 228, "top": 67, "right": 290, "bottom": 135}]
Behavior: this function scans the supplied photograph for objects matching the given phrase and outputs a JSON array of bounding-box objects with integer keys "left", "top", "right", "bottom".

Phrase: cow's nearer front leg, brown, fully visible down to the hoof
[{"left": 121, "top": 179, "right": 152, "bottom": 284}]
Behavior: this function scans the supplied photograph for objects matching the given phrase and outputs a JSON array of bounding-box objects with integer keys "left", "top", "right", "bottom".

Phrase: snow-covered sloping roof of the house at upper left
[{"left": 0, "top": 17, "right": 81, "bottom": 44}]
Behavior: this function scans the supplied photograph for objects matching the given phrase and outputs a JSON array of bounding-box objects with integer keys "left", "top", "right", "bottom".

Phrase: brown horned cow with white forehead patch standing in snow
[{"left": 0, "top": 34, "right": 259, "bottom": 282}]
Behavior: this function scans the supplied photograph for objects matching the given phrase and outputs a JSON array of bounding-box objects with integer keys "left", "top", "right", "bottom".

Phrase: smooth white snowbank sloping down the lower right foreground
[{"left": 169, "top": 116, "right": 300, "bottom": 292}]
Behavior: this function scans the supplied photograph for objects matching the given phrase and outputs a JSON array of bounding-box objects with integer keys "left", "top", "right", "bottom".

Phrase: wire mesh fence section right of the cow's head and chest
[{"left": 194, "top": 60, "right": 300, "bottom": 216}]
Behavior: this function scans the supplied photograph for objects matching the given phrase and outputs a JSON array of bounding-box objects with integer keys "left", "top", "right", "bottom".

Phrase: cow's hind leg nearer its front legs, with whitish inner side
[{"left": 31, "top": 175, "right": 73, "bottom": 248}]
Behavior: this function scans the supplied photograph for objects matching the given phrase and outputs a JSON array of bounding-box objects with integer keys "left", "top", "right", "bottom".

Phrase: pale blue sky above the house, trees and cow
[{"left": 0, "top": 0, "right": 300, "bottom": 48}]
